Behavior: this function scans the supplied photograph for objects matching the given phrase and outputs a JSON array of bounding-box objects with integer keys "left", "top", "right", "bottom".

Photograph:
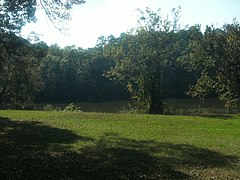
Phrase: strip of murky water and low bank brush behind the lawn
[{"left": 0, "top": 99, "right": 240, "bottom": 115}]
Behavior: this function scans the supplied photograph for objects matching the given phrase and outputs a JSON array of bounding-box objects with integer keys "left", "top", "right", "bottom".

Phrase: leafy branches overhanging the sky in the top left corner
[{"left": 0, "top": 0, "right": 85, "bottom": 33}]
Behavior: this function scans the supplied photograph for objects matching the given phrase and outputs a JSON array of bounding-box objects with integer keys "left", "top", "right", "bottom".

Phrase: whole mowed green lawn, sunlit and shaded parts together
[{"left": 0, "top": 110, "right": 240, "bottom": 179}]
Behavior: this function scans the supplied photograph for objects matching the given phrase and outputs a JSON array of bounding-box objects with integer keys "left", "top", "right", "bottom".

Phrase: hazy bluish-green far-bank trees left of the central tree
[{"left": 37, "top": 45, "right": 127, "bottom": 103}]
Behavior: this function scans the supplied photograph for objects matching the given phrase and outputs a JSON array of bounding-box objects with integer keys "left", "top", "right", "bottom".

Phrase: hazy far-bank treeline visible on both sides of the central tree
[{"left": 35, "top": 41, "right": 196, "bottom": 103}]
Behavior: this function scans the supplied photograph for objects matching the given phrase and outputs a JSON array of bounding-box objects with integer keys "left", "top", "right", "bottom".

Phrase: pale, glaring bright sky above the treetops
[{"left": 22, "top": 0, "right": 240, "bottom": 48}]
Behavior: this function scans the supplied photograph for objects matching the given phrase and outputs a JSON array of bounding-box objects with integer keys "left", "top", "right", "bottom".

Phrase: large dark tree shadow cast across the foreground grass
[{"left": 0, "top": 118, "right": 238, "bottom": 179}]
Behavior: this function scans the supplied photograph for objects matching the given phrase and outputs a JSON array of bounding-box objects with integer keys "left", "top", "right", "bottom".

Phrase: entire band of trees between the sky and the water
[{"left": 0, "top": 5, "right": 240, "bottom": 114}]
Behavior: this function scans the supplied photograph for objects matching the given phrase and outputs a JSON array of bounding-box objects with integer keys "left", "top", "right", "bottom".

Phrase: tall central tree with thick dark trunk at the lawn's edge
[{"left": 105, "top": 8, "right": 180, "bottom": 114}]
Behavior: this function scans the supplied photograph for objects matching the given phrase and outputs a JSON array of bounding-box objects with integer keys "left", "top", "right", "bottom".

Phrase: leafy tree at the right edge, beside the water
[{"left": 189, "top": 21, "right": 240, "bottom": 109}]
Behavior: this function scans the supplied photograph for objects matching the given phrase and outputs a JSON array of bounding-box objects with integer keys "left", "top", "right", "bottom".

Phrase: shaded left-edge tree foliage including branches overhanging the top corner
[{"left": 0, "top": 0, "right": 85, "bottom": 107}]
